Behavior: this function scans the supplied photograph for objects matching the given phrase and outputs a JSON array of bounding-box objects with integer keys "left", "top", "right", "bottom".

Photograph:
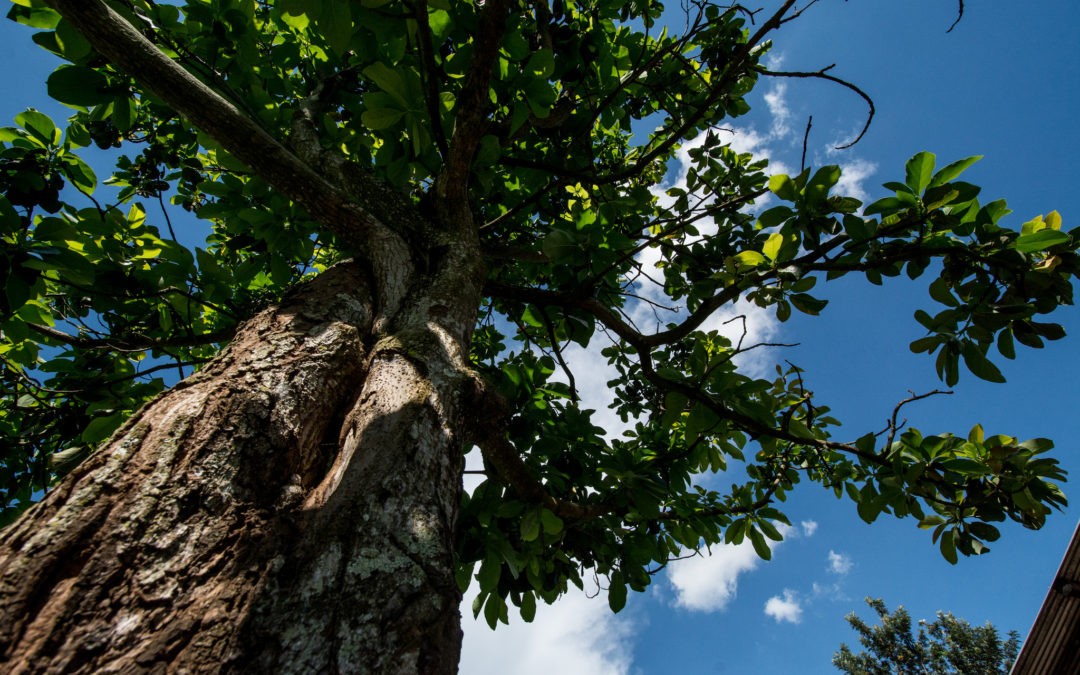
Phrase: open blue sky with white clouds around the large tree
[{"left": 0, "top": 0, "right": 1080, "bottom": 675}]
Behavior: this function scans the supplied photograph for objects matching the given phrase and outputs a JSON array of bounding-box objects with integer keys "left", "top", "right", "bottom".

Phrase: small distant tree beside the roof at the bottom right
[{"left": 833, "top": 597, "right": 1020, "bottom": 675}]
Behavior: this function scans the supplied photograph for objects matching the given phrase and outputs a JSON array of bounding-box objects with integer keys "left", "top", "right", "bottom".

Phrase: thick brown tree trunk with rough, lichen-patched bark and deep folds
[{"left": 0, "top": 257, "right": 478, "bottom": 673}]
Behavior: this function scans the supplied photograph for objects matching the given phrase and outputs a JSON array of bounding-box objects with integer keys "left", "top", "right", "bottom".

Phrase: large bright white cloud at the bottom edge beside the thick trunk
[{"left": 460, "top": 589, "right": 637, "bottom": 675}]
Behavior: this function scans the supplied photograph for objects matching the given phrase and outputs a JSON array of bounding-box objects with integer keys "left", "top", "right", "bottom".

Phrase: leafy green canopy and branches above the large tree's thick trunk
[{"left": 0, "top": 0, "right": 1080, "bottom": 625}]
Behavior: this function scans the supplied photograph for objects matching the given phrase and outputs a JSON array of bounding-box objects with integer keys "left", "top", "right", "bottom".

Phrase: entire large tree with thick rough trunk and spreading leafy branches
[{"left": 0, "top": 0, "right": 1080, "bottom": 673}]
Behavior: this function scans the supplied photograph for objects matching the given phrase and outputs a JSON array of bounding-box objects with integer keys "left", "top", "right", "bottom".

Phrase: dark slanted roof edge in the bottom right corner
[{"left": 1012, "top": 526, "right": 1080, "bottom": 675}]
